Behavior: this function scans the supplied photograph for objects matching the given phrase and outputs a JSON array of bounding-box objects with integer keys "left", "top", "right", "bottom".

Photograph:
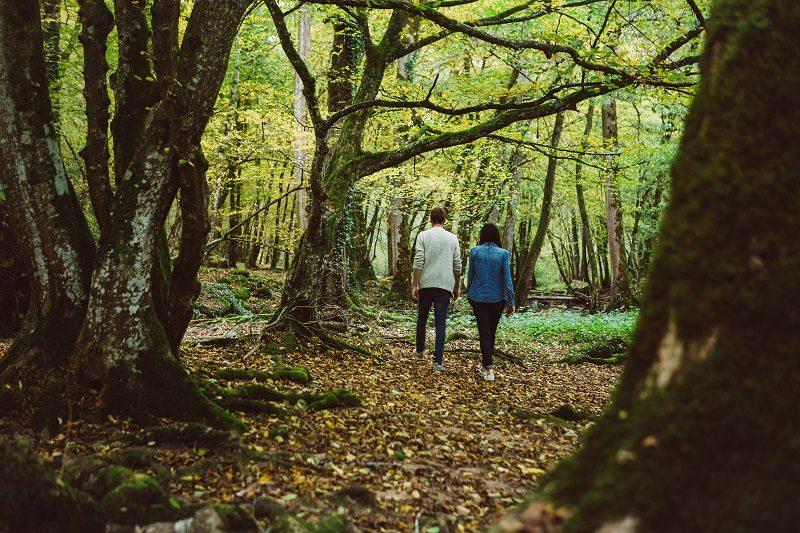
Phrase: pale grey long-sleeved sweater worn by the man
[{"left": 414, "top": 227, "right": 461, "bottom": 293}]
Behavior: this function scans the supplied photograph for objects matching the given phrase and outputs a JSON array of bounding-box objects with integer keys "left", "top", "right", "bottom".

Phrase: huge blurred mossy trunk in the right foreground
[{"left": 496, "top": 0, "right": 800, "bottom": 531}]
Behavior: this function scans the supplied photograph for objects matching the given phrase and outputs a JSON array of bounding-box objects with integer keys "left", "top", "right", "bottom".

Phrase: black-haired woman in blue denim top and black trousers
[{"left": 467, "top": 223, "right": 515, "bottom": 381}]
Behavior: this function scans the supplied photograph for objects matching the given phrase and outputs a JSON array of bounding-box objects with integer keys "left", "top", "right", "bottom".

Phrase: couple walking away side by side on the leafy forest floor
[{"left": 411, "top": 207, "right": 514, "bottom": 381}]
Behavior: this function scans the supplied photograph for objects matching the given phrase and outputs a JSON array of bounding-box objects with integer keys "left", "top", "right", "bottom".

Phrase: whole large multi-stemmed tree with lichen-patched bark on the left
[{"left": 0, "top": 0, "right": 250, "bottom": 426}]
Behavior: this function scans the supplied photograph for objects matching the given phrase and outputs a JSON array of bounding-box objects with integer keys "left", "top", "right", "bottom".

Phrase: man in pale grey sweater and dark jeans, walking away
[{"left": 411, "top": 207, "right": 461, "bottom": 373}]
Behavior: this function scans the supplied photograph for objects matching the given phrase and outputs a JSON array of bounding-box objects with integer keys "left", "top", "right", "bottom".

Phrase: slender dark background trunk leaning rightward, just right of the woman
[{"left": 514, "top": 111, "right": 564, "bottom": 307}]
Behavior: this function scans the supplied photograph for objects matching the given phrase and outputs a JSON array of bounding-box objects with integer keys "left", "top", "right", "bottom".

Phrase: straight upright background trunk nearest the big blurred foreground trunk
[{"left": 602, "top": 98, "right": 633, "bottom": 309}]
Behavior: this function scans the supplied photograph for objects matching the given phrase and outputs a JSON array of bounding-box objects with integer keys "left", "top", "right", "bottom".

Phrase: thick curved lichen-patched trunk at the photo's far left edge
[{"left": 0, "top": 1, "right": 94, "bottom": 410}]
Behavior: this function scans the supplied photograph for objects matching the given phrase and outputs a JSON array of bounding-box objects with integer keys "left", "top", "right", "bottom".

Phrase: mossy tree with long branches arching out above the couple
[{"left": 266, "top": 0, "right": 702, "bottom": 331}]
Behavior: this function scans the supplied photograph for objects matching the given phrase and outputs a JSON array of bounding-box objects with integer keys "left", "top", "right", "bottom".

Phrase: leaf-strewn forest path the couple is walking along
[{"left": 181, "top": 318, "right": 619, "bottom": 531}]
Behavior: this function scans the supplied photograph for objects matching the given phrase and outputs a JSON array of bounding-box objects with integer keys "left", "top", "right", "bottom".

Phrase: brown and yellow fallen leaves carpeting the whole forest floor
[{"left": 0, "top": 294, "right": 620, "bottom": 531}]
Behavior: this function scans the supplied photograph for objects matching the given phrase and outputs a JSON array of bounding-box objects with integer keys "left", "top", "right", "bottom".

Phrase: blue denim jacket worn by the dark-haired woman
[{"left": 467, "top": 243, "right": 514, "bottom": 305}]
